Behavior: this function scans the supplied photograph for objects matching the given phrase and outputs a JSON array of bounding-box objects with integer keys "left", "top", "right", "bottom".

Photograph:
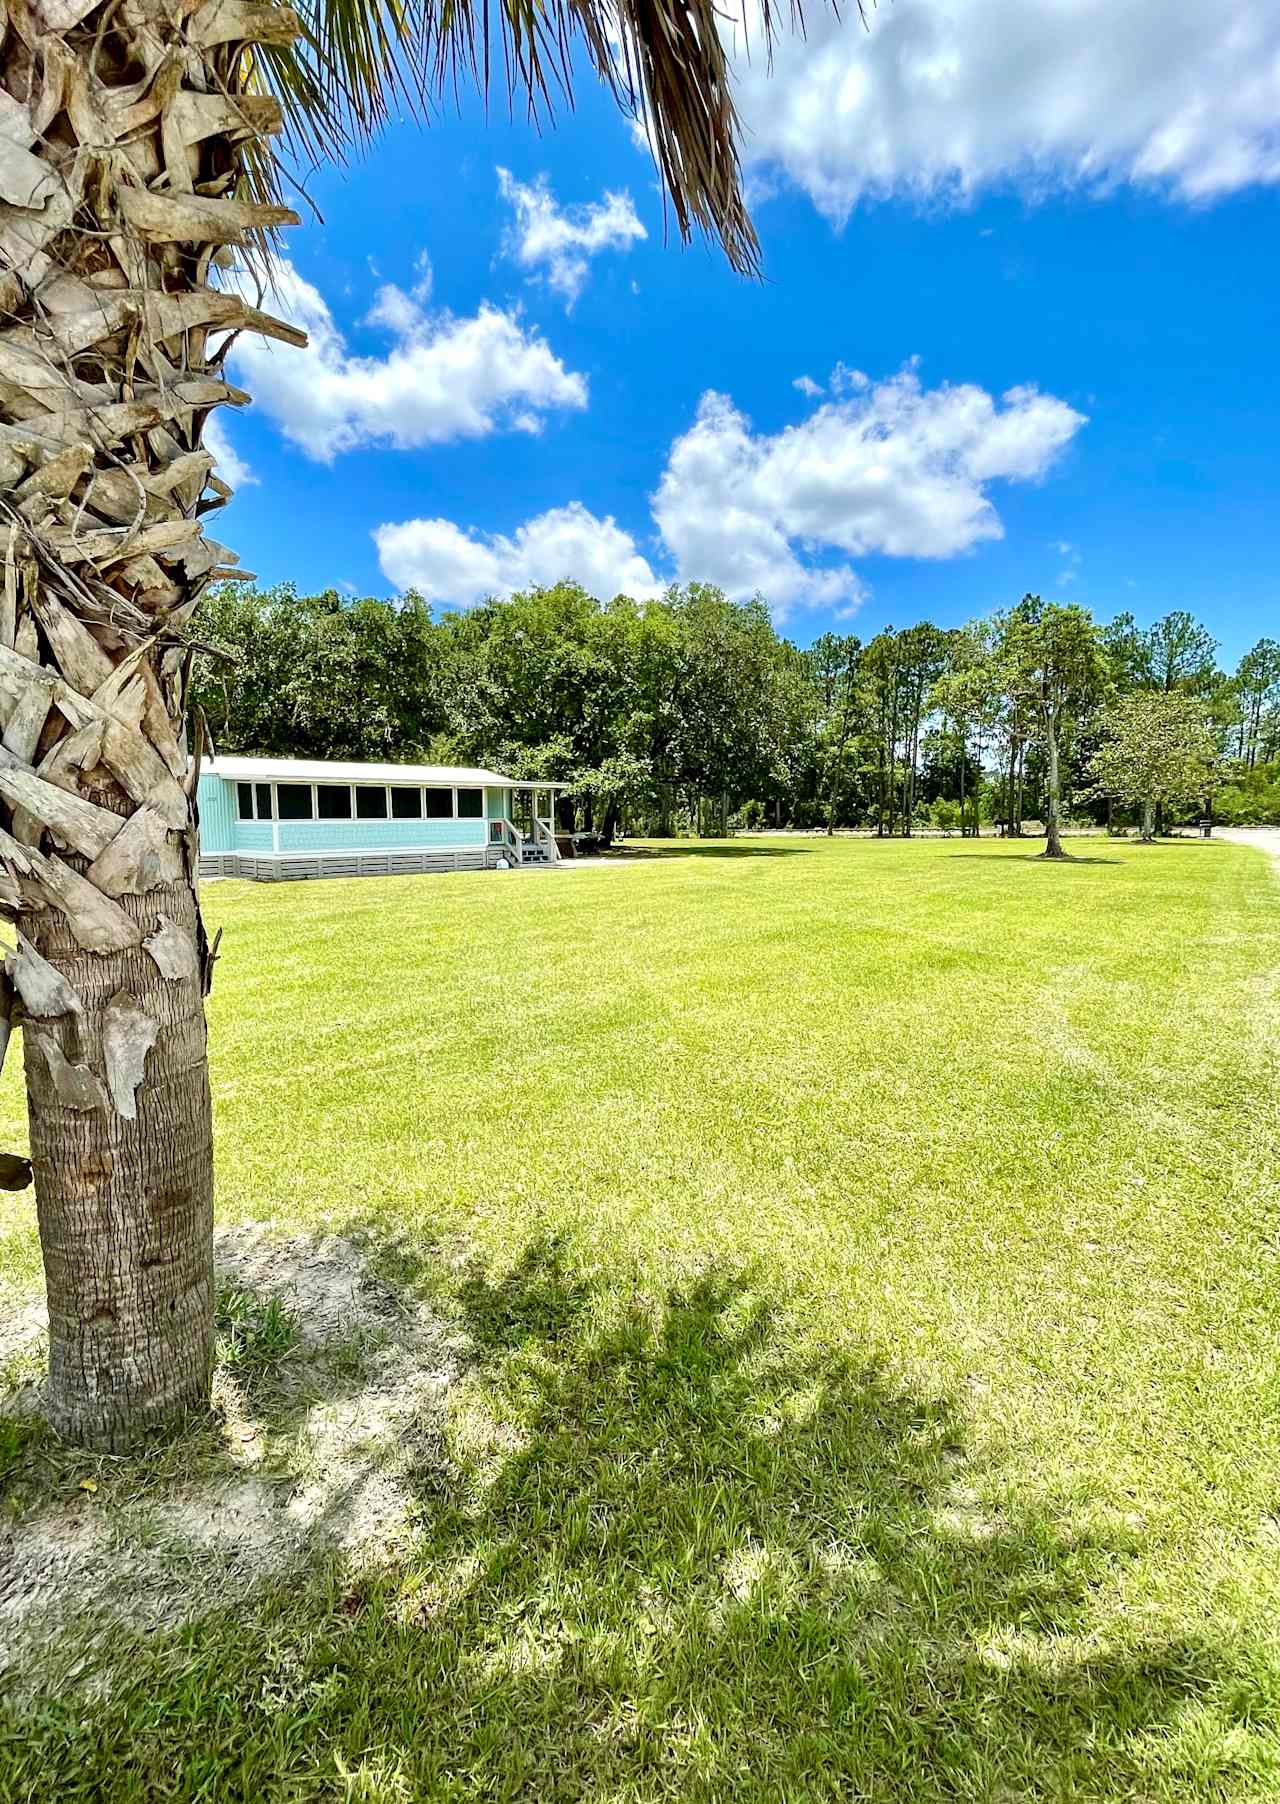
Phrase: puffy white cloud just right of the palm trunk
[{"left": 231, "top": 260, "right": 586, "bottom": 464}]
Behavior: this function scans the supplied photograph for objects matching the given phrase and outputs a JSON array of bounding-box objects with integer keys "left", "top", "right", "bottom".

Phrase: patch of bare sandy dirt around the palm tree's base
[{"left": 0, "top": 1227, "right": 465, "bottom": 1665}]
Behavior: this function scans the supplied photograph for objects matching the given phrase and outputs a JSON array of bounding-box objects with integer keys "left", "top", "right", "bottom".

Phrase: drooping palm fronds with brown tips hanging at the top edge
[{"left": 247, "top": 0, "right": 850, "bottom": 274}]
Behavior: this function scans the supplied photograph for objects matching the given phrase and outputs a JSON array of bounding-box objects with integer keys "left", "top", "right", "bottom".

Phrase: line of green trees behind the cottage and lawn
[{"left": 195, "top": 583, "right": 1280, "bottom": 848}]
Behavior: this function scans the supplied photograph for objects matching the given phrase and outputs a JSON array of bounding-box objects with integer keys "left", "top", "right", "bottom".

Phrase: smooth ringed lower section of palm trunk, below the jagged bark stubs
[{"left": 23, "top": 865, "right": 213, "bottom": 1449}]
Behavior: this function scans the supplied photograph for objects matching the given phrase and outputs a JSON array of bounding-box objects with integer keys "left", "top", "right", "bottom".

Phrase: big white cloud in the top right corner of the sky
[{"left": 736, "top": 0, "right": 1280, "bottom": 222}]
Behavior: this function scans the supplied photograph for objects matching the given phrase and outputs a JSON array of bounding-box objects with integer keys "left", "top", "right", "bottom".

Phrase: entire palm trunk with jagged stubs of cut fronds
[{"left": 0, "top": 0, "right": 305, "bottom": 1449}]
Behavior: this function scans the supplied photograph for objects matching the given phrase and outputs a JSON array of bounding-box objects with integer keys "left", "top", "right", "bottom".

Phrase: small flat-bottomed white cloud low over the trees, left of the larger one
[{"left": 373, "top": 502, "right": 662, "bottom": 608}]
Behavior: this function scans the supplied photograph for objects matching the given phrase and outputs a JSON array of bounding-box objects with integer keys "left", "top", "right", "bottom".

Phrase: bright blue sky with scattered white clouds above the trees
[{"left": 216, "top": 0, "right": 1280, "bottom": 664}]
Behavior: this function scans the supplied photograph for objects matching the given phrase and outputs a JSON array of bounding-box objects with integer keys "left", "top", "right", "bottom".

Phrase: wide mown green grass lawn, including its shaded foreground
[{"left": 0, "top": 839, "right": 1280, "bottom": 1804}]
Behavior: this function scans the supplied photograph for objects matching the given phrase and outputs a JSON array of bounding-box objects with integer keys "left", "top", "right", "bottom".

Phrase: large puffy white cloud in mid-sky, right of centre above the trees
[{"left": 653, "top": 366, "right": 1083, "bottom": 610}]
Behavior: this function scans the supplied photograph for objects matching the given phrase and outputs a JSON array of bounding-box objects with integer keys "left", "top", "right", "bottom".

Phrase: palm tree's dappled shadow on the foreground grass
[{"left": 0, "top": 1239, "right": 1276, "bottom": 1804}]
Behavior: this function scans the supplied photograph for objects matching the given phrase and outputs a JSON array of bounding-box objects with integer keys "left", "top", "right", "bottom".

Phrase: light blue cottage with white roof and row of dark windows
[{"left": 198, "top": 758, "right": 562, "bottom": 880}]
